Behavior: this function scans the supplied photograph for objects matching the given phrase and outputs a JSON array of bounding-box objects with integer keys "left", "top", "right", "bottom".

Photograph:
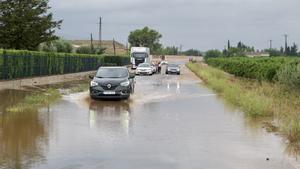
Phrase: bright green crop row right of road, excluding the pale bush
[{"left": 206, "top": 57, "right": 300, "bottom": 81}]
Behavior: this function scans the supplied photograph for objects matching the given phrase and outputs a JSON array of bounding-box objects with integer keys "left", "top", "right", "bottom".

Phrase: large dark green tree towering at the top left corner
[{"left": 0, "top": 0, "right": 62, "bottom": 50}]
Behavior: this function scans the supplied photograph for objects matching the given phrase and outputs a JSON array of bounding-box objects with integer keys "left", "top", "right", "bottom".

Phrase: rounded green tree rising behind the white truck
[{"left": 128, "top": 27, "right": 162, "bottom": 53}]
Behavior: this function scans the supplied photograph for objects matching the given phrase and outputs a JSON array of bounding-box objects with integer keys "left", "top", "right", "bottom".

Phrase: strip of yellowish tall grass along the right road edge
[{"left": 187, "top": 63, "right": 300, "bottom": 143}]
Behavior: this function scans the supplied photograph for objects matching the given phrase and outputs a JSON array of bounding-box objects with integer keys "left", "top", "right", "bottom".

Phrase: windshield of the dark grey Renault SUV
[{"left": 96, "top": 68, "right": 128, "bottom": 78}]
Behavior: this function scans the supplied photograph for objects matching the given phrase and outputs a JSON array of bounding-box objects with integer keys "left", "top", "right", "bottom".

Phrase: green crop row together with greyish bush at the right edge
[{"left": 206, "top": 57, "right": 300, "bottom": 90}]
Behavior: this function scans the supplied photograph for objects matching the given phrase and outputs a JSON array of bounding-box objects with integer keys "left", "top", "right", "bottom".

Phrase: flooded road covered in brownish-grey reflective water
[{"left": 0, "top": 57, "right": 293, "bottom": 169}]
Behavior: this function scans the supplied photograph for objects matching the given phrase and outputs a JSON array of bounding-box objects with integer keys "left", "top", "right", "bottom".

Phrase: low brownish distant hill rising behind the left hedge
[{"left": 70, "top": 40, "right": 127, "bottom": 55}]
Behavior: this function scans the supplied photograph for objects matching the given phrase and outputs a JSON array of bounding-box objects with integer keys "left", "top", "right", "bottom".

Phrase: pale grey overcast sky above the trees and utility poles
[{"left": 50, "top": 0, "right": 300, "bottom": 50}]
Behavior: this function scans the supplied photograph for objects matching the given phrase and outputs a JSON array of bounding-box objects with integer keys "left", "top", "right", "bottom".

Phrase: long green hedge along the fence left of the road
[{"left": 0, "top": 50, "right": 130, "bottom": 79}]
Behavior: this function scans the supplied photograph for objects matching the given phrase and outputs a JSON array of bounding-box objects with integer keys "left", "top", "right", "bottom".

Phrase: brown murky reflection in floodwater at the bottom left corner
[{"left": 0, "top": 90, "right": 48, "bottom": 169}]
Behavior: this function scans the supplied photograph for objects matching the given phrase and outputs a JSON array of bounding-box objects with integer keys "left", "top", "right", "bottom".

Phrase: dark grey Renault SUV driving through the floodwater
[{"left": 90, "top": 67, "right": 135, "bottom": 99}]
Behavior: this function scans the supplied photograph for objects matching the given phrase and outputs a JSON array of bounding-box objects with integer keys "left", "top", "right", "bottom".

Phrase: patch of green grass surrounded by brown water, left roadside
[{"left": 6, "top": 89, "right": 61, "bottom": 113}]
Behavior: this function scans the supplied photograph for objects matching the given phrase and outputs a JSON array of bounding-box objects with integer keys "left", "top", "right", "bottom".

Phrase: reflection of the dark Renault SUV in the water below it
[{"left": 89, "top": 101, "right": 131, "bottom": 135}]
